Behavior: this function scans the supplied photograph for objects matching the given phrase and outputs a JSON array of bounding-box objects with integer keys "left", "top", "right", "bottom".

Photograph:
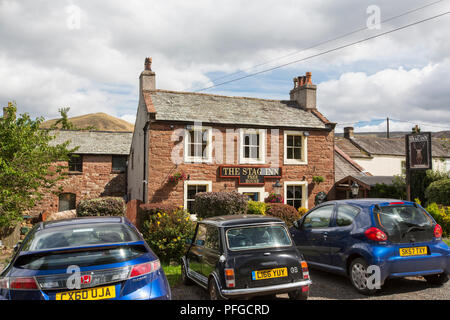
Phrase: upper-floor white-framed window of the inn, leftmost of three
[{"left": 184, "top": 126, "right": 212, "bottom": 163}]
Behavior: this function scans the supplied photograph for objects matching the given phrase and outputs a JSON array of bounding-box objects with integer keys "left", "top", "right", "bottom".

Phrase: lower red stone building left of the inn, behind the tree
[{"left": 30, "top": 130, "right": 132, "bottom": 216}]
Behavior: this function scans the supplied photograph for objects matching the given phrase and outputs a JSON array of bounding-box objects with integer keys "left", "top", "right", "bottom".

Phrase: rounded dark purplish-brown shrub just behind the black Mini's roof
[{"left": 194, "top": 191, "right": 248, "bottom": 218}]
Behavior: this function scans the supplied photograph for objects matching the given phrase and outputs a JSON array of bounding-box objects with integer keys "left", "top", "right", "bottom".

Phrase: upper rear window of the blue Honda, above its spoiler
[{"left": 21, "top": 223, "right": 140, "bottom": 251}]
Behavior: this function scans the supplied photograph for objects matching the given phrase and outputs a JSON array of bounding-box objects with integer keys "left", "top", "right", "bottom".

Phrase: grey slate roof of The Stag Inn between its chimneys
[{"left": 146, "top": 90, "right": 328, "bottom": 129}]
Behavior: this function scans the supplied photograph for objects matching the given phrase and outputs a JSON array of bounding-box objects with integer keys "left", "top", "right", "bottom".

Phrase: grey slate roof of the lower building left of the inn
[{"left": 50, "top": 130, "right": 133, "bottom": 155}]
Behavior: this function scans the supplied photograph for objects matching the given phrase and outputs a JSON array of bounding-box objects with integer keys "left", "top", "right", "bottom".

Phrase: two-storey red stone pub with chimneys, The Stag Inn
[{"left": 127, "top": 60, "right": 335, "bottom": 209}]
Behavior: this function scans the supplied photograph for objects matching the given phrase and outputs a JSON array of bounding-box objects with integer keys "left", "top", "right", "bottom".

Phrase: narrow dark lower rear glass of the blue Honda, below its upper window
[{"left": 14, "top": 245, "right": 147, "bottom": 270}]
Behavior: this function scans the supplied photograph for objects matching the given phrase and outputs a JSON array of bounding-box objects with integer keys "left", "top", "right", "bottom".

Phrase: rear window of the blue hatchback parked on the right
[{"left": 374, "top": 204, "right": 434, "bottom": 242}]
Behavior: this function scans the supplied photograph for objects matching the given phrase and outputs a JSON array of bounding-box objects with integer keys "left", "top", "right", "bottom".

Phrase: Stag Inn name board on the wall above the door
[{"left": 219, "top": 166, "right": 281, "bottom": 185}]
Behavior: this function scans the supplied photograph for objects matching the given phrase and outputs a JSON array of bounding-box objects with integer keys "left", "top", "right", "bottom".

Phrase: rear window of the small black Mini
[{"left": 226, "top": 225, "right": 292, "bottom": 250}]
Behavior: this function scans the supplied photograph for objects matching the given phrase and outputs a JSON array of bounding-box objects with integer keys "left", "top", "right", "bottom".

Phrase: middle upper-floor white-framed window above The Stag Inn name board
[{"left": 239, "top": 129, "right": 266, "bottom": 164}]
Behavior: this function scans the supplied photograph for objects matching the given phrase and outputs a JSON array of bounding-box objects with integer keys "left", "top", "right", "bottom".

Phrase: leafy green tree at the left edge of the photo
[{"left": 0, "top": 103, "right": 76, "bottom": 227}]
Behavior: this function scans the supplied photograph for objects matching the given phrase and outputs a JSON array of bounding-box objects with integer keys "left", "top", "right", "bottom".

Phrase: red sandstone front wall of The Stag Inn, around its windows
[{"left": 144, "top": 123, "right": 334, "bottom": 208}]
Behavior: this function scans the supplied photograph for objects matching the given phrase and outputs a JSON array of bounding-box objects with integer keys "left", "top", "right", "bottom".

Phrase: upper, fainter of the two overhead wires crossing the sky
[{"left": 194, "top": 0, "right": 445, "bottom": 89}]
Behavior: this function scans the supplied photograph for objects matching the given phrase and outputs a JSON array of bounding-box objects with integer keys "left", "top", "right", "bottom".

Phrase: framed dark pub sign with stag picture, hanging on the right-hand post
[{"left": 405, "top": 132, "right": 432, "bottom": 170}]
